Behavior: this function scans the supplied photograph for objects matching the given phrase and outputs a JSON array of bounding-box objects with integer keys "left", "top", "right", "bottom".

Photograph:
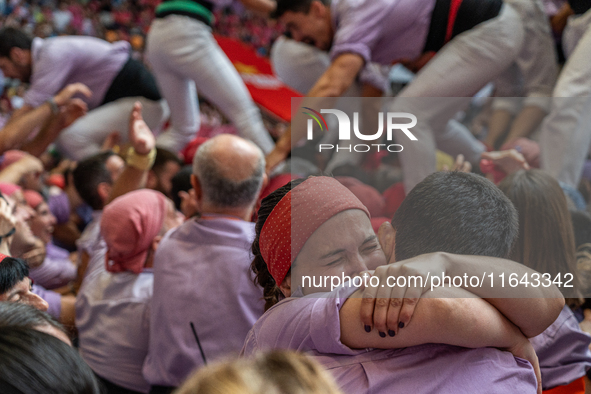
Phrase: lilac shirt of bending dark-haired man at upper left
[{"left": 24, "top": 36, "right": 131, "bottom": 109}]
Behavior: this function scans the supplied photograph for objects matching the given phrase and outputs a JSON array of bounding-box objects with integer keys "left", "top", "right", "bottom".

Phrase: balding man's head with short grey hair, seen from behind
[{"left": 193, "top": 134, "right": 265, "bottom": 208}]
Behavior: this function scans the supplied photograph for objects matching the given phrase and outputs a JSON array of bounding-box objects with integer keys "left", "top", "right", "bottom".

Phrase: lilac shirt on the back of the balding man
[{"left": 143, "top": 218, "right": 264, "bottom": 386}]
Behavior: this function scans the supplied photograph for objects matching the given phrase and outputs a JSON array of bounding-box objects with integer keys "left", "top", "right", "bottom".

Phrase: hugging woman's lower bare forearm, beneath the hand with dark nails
[{"left": 340, "top": 288, "right": 523, "bottom": 349}]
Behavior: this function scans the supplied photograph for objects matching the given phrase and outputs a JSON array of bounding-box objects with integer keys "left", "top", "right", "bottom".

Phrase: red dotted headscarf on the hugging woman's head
[{"left": 259, "top": 176, "right": 371, "bottom": 285}]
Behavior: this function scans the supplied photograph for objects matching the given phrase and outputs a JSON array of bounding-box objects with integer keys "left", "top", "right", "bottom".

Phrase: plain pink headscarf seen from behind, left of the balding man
[{"left": 101, "top": 189, "right": 166, "bottom": 274}]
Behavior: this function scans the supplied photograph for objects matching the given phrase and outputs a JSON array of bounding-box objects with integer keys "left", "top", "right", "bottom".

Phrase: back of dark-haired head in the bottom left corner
[{"left": 0, "top": 327, "right": 100, "bottom": 394}]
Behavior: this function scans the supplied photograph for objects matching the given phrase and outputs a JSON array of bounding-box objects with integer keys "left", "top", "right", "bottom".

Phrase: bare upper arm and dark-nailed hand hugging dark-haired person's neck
[{"left": 361, "top": 253, "right": 564, "bottom": 338}]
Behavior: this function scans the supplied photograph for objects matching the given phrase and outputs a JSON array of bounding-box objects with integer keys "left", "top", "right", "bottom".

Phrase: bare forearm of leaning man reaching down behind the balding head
[{"left": 266, "top": 53, "right": 365, "bottom": 172}]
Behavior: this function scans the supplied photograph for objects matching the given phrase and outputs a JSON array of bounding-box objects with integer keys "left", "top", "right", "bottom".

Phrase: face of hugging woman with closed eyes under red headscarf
[{"left": 291, "top": 209, "right": 386, "bottom": 295}]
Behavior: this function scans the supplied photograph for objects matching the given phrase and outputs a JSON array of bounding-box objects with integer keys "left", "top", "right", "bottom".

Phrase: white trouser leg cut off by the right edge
[{"left": 540, "top": 10, "right": 591, "bottom": 187}]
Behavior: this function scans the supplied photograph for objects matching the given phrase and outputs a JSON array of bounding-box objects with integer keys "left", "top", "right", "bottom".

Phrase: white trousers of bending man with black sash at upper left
[{"left": 56, "top": 97, "right": 169, "bottom": 160}]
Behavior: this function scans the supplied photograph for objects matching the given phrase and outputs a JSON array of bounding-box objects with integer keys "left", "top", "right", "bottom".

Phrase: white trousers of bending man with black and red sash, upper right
[{"left": 390, "top": 4, "right": 525, "bottom": 193}]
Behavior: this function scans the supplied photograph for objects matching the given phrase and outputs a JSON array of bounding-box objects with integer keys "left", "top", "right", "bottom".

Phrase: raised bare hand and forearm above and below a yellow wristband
[{"left": 109, "top": 102, "right": 156, "bottom": 202}]
